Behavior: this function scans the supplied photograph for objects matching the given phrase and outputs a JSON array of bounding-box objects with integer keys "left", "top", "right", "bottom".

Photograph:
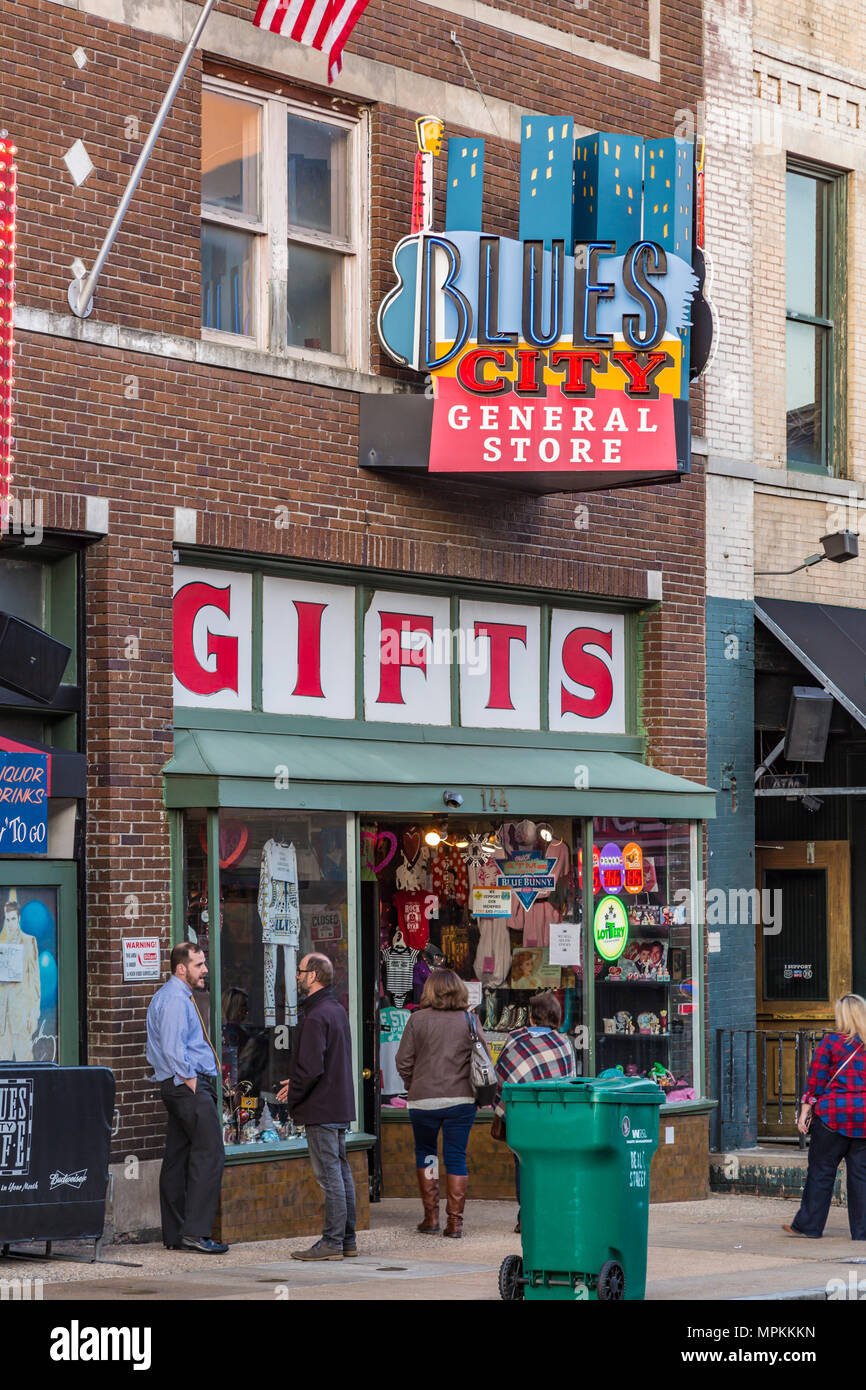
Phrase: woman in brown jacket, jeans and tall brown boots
[{"left": 396, "top": 970, "right": 487, "bottom": 1240}]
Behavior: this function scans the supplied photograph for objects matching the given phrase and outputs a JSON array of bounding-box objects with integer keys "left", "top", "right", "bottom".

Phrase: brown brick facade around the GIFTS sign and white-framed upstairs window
[{"left": 0, "top": 0, "right": 716, "bottom": 1225}]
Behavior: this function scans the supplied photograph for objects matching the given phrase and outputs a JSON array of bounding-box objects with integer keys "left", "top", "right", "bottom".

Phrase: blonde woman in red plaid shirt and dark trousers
[{"left": 783, "top": 994, "right": 866, "bottom": 1240}]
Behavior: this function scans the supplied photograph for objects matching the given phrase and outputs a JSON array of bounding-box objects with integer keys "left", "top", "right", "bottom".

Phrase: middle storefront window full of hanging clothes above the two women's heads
[{"left": 361, "top": 816, "right": 587, "bottom": 1108}]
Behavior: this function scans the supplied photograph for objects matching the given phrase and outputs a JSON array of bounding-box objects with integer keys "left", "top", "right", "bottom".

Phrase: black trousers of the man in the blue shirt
[{"left": 160, "top": 1076, "right": 225, "bottom": 1245}]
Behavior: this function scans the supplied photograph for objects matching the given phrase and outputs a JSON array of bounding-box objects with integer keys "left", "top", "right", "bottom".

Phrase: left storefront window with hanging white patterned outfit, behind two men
[{"left": 185, "top": 810, "right": 356, "bottom": 1144}]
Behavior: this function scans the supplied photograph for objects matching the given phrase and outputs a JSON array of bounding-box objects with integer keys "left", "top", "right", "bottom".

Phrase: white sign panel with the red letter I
[{"left": 261, "top": 575, "right": 354, "bottom": 719}]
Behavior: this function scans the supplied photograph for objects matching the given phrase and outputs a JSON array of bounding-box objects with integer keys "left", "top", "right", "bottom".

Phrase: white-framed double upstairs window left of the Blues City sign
[{"left": 202, "top": 79, "right": 366, "bottom": 367}]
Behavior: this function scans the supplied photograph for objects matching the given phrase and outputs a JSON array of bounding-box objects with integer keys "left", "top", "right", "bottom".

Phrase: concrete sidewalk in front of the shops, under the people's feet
[{"left": 0, "top": 1195, "right": 866, "bottom": 1302}]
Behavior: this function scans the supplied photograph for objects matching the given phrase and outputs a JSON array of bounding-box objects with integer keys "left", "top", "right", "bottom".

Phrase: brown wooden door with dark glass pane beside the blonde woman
[{"left": 756, "top": 840, "right": 852, "bottom": 1138}]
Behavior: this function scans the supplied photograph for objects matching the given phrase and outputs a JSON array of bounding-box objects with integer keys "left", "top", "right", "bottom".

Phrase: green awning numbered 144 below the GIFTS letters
[{"left": 164, "top": 728, "right": 716, "bottom": 820}]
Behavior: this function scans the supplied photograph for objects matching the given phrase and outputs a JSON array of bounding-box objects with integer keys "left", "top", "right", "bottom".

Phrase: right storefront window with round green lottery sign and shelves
[{"left": 592, "top": 819, "right": 699, "bottom": 1101}]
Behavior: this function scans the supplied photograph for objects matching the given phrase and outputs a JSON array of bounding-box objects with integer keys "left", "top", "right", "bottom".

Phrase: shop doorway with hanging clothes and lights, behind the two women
[{"left": 360, "top": 808, "right": 587, "bottom": 1200}]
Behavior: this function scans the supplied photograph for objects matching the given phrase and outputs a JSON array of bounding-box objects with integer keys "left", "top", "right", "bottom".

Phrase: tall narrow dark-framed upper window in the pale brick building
[{"left": 785, "top": 163, "right": 845, "bottom": 474}]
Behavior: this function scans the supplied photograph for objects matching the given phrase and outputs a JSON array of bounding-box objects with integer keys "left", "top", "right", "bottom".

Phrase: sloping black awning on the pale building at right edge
[{"left": 755, "top": 599, "right": 866, "bottom": 728}]
